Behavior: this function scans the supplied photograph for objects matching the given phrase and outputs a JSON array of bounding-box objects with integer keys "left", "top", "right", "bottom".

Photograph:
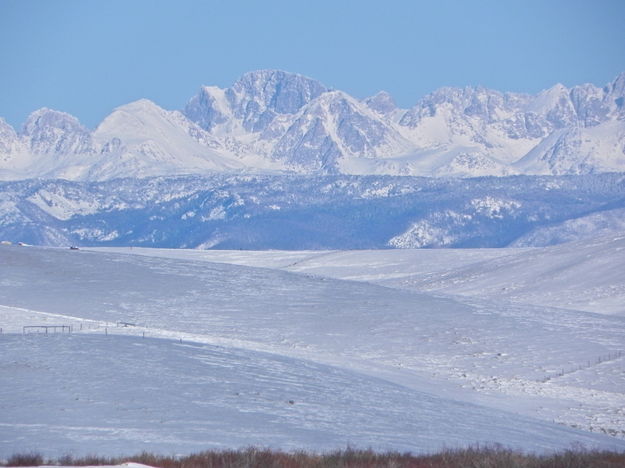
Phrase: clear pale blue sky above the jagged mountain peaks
[{"left": 0, "top": 0, "right": 625, "bottom": 128}]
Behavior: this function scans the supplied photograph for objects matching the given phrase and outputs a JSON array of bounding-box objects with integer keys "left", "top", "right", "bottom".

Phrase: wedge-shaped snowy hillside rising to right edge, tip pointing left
[{"left": 386, "top": 231, "right": 625, "bottom": 317}]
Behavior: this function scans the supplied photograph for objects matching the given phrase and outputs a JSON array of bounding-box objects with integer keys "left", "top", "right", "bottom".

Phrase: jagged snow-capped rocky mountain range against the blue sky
[{"left": 0, "top": 70, "right": 625, "bottom": 181}]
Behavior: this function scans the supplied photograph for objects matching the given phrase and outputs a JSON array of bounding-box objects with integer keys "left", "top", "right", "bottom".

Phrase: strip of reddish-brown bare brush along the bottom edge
[{"left": 3, "top": 447, "right": 625, "bottom": 468}]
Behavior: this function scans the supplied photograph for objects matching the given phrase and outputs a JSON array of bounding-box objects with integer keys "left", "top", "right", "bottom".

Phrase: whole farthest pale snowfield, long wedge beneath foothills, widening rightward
[{"left": 144, "top": 232, "right": 625, "bottom": 317}]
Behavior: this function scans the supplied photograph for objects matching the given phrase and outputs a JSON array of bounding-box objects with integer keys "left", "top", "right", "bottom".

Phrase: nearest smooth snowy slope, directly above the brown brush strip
[{"left": 7, "top": 333, "right": 622, "bottom": 456}]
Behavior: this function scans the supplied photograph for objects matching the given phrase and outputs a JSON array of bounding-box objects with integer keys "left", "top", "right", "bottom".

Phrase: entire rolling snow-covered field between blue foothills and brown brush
[{"left": 0, "top": 236, "right": 625, "bottom": 458}]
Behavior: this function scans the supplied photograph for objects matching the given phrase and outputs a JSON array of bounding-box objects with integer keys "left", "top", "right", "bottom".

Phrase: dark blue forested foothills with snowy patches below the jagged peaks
[{"left": 0, "top": 174, "right": 625, "bottom": 250}]
